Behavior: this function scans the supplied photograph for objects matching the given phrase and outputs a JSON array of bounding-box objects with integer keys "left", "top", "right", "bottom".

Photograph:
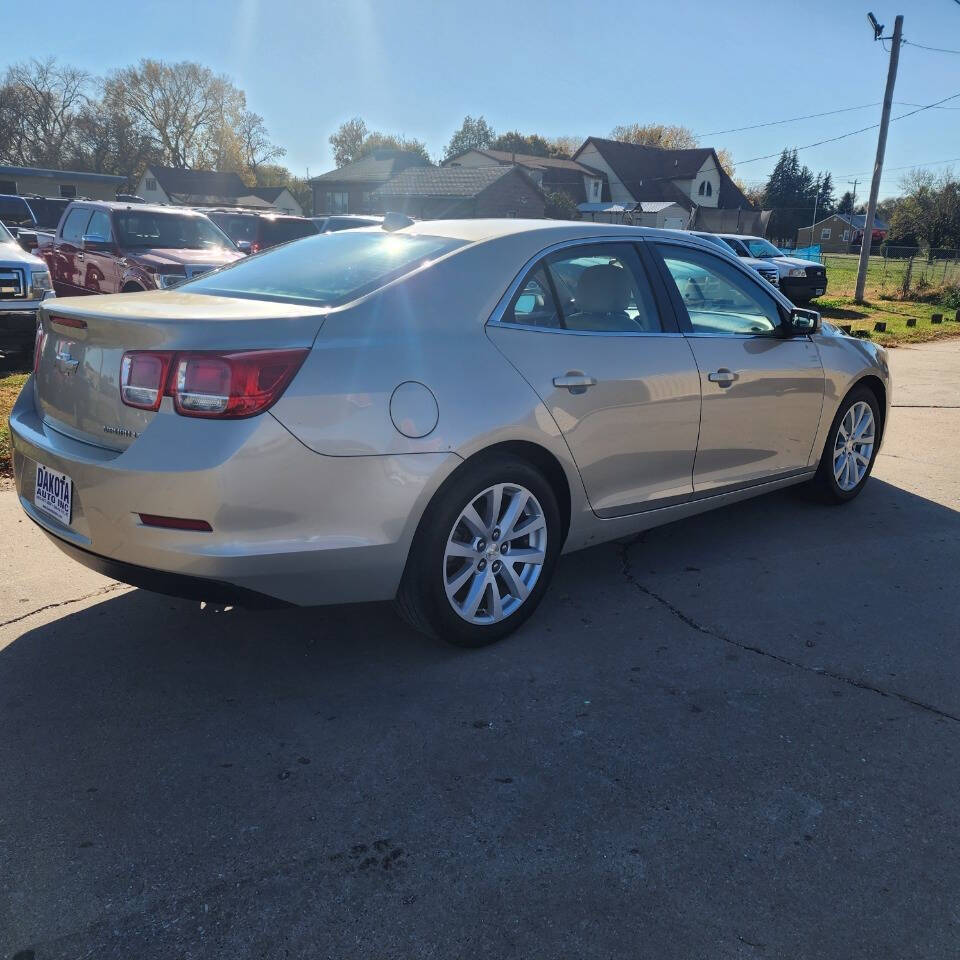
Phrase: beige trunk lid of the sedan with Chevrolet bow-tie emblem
[{"left": 34, "top": 291, "right": 324, "bottom": 451}]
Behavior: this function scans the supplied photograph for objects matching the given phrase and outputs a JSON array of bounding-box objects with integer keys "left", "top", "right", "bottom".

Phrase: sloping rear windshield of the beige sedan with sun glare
[{"left": 178, "top": 230, "right": 465, "bottom": 306}]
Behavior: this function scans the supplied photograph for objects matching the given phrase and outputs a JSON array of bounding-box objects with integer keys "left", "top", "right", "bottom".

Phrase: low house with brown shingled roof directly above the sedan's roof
[{"left": 370, "top": 170, "right": 546, "bottom": 220}]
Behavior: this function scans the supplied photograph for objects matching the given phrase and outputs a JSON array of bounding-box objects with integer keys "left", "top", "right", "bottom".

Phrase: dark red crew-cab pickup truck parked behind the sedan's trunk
[{"left": 44, "top": 200, "right": 243, "bottom": 297}]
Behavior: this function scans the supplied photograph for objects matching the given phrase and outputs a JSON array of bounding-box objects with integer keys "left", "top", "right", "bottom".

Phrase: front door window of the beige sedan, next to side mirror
[{"left": 657, "top": 244, "right": 780, "bottom": 336}]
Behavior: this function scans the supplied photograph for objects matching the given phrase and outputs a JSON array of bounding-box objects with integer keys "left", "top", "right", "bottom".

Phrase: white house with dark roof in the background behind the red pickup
[{"left": 137, "top": 164, "right": 303, "bottom": 216}]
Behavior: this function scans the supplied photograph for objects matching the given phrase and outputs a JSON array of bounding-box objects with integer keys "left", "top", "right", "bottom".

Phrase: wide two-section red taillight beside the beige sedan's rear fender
[{"left": 120, "top": 349, "right": 310, "bottom": 419}]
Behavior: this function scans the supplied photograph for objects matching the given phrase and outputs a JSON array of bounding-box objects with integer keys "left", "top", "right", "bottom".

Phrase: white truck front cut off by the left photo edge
[{"left": 0, "top": 223, "right": 53, "bottom": 357}]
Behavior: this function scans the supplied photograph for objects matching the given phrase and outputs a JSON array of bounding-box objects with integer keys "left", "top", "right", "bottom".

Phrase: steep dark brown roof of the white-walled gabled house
[{"left": 574, "top": 137, "right": 752, "bottom": 210}]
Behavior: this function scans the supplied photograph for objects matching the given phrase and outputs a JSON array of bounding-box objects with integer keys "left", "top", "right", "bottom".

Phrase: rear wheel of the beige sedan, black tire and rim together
[{"left": 397, "top": 454, "right": 562, "bottom": 647}]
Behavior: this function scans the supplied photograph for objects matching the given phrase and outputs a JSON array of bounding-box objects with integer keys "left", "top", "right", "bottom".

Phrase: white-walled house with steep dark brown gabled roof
[{"left": 573, "top": 137, "right": 753, "bottom": 211}]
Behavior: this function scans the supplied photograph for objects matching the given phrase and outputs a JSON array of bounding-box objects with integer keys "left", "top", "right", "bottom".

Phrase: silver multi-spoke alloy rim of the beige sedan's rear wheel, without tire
[{"left": 443, "top": 483, "right": 547, "bottom": 625}]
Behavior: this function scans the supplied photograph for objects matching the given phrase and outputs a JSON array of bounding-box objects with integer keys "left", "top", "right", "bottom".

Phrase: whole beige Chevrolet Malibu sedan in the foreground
[{"left": 11, "top": 220, "right": 890, "bottom": 646}]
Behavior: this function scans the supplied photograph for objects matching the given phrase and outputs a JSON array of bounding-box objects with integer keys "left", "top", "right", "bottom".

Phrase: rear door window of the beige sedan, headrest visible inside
[{"left": 503, "top": 243, "right": 663, "bottom": 333}]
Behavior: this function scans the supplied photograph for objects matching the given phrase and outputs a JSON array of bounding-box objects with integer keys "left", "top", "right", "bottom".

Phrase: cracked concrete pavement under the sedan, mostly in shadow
[{"left": 0, "top": 341, "right": 960, "bottom": 960}]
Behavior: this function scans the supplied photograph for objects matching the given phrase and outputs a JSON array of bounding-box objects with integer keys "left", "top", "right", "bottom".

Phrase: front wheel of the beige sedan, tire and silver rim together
[{"left": 810, "top": 387, "right": 881, "bottom": 504}]
